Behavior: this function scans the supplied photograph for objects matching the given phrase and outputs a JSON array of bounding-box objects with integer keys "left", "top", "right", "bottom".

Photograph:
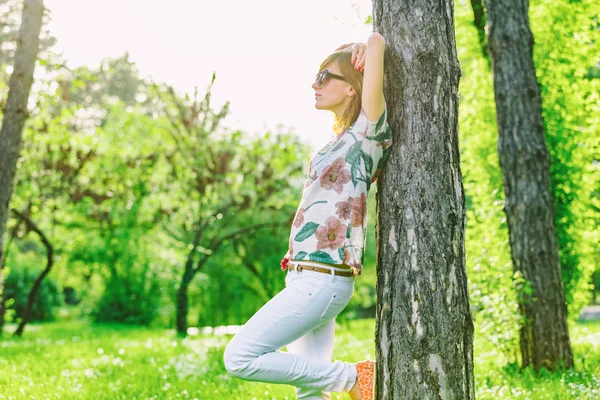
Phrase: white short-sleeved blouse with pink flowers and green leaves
[{"left": 281, "top": 105, "right": 392, "bottom": 276}]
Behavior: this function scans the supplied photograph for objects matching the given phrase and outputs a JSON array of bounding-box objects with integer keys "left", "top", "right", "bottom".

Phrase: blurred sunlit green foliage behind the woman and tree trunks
[{"left": 0, "top": 0, "right": 600, "bottom": 370}]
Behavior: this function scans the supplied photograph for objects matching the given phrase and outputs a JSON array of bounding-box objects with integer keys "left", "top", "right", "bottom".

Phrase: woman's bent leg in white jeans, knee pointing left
[{"left": 223, "top": 273, "right": 356, "bottom": 392}]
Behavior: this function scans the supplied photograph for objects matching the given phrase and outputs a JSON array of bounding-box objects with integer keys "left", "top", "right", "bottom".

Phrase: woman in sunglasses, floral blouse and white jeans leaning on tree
[{"left": 223, "top": 33, "right": 392, "bottom": 400}]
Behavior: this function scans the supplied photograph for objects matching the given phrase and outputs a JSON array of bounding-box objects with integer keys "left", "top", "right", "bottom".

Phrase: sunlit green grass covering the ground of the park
[{"left": 0, "top": 319, "right": 600, "bottom": 400}]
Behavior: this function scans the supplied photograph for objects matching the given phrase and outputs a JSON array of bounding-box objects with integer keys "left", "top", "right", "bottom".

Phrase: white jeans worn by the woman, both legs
[{"left": 223, "top": 263, "right": 356, "bottom": 400}]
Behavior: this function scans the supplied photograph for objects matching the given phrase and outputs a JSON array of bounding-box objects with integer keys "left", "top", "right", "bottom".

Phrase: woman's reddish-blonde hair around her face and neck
[{"left": 319, "top": 50, "right": 363, "bottom": 134}]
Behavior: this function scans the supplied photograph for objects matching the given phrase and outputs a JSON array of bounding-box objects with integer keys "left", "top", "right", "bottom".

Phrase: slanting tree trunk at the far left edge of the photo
[{"left": 0, "top": 0, "right": 44, "bottom": 333}]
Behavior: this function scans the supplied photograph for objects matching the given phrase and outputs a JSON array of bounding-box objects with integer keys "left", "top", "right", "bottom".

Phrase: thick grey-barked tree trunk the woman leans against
[{"left": 373, "top": 0, "right": 475, "bottom": 400}]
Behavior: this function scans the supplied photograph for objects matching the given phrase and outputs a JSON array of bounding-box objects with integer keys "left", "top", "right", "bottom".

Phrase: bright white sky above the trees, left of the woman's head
[{"left": 45, "top": 0, "right": 373, "bottom": 151}]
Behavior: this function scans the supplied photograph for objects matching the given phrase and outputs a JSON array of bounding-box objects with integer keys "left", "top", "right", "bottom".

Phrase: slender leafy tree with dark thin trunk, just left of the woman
[{"left": 157, "top": 83, "right": 296, "bottom": 337}]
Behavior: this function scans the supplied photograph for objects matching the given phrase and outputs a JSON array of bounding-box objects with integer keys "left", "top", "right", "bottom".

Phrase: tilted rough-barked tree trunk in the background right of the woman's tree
[{"left": 486, "top": 0, "right": 573, "bottom": 370}]
